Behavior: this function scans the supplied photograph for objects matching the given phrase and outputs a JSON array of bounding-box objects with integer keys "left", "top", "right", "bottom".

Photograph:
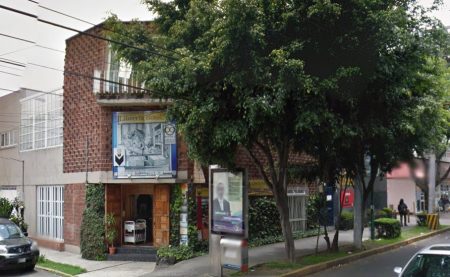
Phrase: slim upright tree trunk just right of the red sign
[{"left": 353, "top": 177, "right": 364, "bottom": 249}]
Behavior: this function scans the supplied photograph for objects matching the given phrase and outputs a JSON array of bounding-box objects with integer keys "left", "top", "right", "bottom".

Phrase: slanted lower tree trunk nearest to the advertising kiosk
[{"left": 275, "top": 190, "right": 295, "bottom": 262}]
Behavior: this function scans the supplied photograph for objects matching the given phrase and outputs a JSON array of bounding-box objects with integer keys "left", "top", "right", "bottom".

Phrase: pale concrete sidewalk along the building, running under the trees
[{"left": 41, "top": 213, "right": 450, "bottom": 277}]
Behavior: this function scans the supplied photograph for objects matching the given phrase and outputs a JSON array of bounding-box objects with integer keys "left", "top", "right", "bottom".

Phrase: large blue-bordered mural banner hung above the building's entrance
[{"left": 112, "top": 111, "right": 177, "bottom": 179}]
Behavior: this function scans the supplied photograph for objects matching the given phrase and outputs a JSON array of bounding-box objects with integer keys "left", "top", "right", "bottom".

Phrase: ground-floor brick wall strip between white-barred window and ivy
[{"left": 64, "top": 184, "right": 86, "bottom": 245}]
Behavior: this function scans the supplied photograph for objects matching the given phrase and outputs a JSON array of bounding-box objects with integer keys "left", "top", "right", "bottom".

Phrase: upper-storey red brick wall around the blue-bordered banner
[{"left": 63, "top": 25, "right": 191, "bottom": 173}]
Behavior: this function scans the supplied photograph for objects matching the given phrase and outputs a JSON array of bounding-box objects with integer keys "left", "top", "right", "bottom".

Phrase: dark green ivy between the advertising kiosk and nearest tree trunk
[{"left": 248, "top": 196, "right": 281, "bottom": 237}]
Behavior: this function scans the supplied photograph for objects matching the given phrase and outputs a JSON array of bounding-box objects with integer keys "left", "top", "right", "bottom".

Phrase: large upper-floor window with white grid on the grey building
[{"left": 20, "top": 94, "right": 63, "bottom": 151}]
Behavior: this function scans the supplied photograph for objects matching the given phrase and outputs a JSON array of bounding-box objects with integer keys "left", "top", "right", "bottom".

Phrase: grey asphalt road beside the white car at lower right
[{"left": 310, "top": 229, "right": 450, "bottom": 277}]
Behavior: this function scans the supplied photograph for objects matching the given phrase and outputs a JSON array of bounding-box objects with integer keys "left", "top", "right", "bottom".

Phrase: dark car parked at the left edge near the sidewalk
[{"left": 0, "top": 218, "right": 39, "bottom": 270}]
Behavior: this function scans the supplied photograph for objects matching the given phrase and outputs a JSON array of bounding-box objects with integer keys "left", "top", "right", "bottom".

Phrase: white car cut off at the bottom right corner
[{"left": 394, "top": 244, "right": 450, "bottom": 277}]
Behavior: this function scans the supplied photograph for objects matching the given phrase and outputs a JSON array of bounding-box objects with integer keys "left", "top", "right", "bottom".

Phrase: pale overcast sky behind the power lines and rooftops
[{"left": 0, "top": 0, "right": 450, "bottom": 96}]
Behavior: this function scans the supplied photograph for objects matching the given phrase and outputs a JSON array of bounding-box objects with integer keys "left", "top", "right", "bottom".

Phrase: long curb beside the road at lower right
[{"left": 281, "top": 227, "right": 450, "bottom": 277}]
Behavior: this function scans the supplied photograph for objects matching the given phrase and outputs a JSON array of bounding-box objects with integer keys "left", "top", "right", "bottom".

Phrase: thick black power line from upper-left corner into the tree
[{"left": 0, "top": 5, "right": 177, "bottom": 60}]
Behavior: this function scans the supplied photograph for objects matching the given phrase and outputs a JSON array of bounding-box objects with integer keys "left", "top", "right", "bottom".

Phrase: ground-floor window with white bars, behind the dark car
[{"left": 37, "top": 186, "right": 64, "bottom": 240}]
